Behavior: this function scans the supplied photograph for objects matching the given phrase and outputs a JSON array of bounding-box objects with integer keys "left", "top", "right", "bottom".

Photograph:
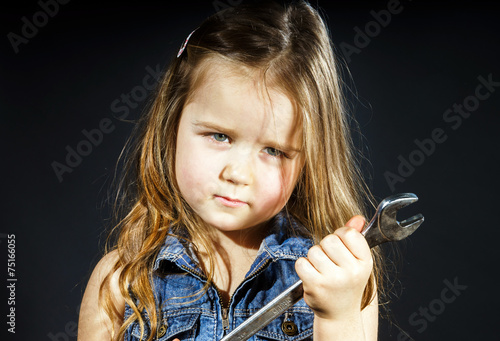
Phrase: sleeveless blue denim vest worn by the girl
[{"left": 125, "top": 212, "right": 314, "bottom": 341}]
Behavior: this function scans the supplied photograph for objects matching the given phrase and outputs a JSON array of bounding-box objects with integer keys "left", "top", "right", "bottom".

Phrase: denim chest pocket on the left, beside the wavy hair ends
[{"left": 131, "top": 309, "right": 201, "bottom": 341}]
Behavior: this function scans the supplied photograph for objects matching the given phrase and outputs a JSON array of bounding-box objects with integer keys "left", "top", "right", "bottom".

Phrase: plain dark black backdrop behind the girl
[{"left": 0, "top": 0, "right": 500, "bottom": 340}]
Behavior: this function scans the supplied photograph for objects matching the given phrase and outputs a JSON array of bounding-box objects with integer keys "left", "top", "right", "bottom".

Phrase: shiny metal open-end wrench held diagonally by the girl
[{"left": 220, "top": 193, "right": 424, "bottom": 341}]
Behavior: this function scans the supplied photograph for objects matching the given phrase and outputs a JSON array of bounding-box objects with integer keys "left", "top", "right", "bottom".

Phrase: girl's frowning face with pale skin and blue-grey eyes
[{"left": 175, "top": 63, "right": 303, "bottom": 242}]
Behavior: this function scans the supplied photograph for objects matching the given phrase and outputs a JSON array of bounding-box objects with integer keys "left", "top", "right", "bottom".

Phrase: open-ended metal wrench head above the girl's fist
[{"left": 365, "top": 193, "right": 424, "bottom": 247}]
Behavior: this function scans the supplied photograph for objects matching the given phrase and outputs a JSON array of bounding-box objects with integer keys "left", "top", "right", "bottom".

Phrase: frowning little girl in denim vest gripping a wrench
[{"left": 78, "top": 1, "right": 381, "bottom": 341}]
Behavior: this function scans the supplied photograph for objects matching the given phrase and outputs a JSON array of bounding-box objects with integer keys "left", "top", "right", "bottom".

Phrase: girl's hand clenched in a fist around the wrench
[{"left": 295, "top": 216, "right": 373, "bottom": 319}]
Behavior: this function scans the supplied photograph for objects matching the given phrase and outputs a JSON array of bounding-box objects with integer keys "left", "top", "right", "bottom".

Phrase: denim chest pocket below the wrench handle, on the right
[{"left": 234, "top": 307, "right": 314, "bottom": 341}]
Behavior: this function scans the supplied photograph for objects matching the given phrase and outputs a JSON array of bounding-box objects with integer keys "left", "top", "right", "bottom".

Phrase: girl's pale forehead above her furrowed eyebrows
[{"left": 183, "top": 58, "right": 301, "bottom": 147}]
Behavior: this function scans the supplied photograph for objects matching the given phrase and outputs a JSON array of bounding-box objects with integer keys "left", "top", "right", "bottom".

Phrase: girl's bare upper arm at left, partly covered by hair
[{"left": 78, "top": 251, "right": 125, "bottom": 341}]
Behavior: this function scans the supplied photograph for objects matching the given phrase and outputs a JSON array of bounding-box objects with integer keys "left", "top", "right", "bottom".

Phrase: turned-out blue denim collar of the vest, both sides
[{"left": 153, "top": 210, "right": 313, "bottom": 277}]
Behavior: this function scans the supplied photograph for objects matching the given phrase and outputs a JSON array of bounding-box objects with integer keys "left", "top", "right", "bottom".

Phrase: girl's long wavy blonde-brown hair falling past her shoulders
[{"left": 101, "top": 1, "right": 383, "bottom": 340}]
